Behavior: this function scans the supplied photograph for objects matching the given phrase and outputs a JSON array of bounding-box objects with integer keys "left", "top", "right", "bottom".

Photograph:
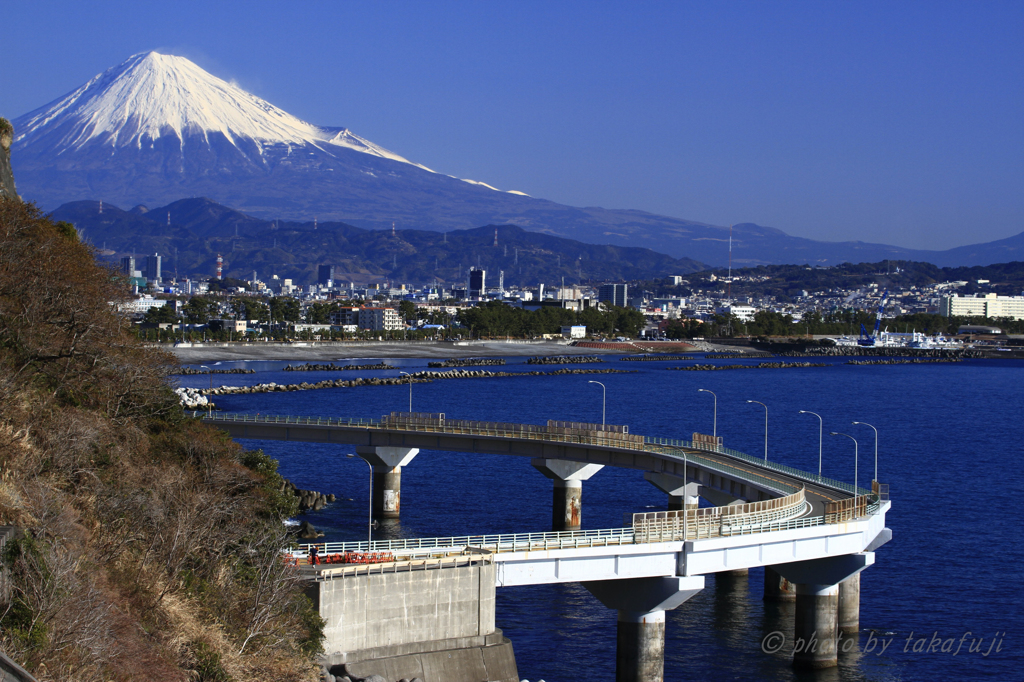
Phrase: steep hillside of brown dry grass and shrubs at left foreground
[{"left": 0, "top": 201, "right": 323, "bottom": 682}]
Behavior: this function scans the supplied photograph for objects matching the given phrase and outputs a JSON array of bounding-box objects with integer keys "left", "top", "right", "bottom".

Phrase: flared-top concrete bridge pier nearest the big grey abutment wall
[{"left": 583, "top": 576, "right": 705, "bottom": 682}]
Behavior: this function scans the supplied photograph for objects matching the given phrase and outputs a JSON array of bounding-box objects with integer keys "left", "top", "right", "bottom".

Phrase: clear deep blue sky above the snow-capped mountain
[{"left": 0, "top": 0, "right": 1024, "bottom": 249}]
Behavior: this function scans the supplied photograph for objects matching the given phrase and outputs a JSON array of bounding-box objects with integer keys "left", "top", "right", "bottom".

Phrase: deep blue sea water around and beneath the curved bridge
[{"left": 181, "top": 357, "right": 1024, "bottom": 682}]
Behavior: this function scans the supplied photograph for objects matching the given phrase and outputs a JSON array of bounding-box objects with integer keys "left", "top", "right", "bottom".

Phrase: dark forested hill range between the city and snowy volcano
[{"left": 52, "top": 198, "right": 707, "bottom": 286}]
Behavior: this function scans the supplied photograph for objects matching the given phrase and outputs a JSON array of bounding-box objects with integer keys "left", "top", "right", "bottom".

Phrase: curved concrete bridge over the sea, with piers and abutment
[{"left": 197, "top": 413, "right": 891, "bottom": 682}]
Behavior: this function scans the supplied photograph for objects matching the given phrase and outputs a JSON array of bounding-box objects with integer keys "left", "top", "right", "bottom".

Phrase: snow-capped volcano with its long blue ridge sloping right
[{"left": 12, "top": 52, "right": 1024, "bottom": 266}]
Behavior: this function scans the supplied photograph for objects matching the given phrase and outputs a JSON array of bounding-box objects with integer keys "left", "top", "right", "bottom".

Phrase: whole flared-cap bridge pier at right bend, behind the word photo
[{"left": 774, "top": 552, "right": 874, "bottom": 669}]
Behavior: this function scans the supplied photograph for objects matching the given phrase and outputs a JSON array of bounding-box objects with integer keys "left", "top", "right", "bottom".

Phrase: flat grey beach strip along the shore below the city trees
[{"left": 164, "top": 341, "right": 623, "bottom": 365}]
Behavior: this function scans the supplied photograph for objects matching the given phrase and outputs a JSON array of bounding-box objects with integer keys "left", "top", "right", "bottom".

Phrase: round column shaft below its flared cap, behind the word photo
[{"left": 793, "top": 583, "right": 839, "bottom": 670}]
